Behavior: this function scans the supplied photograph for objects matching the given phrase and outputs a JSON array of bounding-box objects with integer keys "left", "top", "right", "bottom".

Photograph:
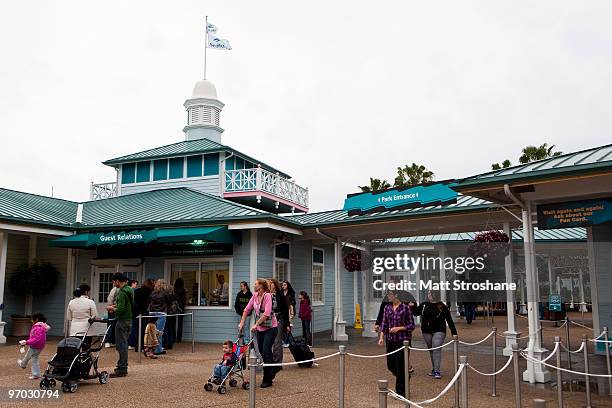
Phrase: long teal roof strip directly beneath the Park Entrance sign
[{"left": 284, "top": 195, "right": 499, "bottom": 227}]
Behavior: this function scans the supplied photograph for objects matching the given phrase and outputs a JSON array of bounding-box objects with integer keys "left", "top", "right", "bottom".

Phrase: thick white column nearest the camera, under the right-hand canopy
[{"left": 522, "top": 201, "right": 552, "bottom": 384}]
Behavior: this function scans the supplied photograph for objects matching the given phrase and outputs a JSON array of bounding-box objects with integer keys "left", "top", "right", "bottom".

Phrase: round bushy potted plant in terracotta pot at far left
[{"left": 8, "top": 262, "right": 59, "bottom": 336}]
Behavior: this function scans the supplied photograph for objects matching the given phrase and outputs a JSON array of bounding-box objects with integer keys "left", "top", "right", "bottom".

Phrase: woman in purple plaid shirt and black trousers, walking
[{"left": 378, "top": 291, "right": 414, "bottom": 397}]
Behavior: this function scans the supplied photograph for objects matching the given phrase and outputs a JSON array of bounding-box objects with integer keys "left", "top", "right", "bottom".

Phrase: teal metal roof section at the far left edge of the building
[{"left": 0, "top": 188, "right": 77, "bottom": 227}]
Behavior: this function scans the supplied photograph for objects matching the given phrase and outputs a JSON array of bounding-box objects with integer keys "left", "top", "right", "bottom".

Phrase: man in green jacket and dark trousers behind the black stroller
[{"left": 107, "top": 273, "right": 134, "bottom": 377}]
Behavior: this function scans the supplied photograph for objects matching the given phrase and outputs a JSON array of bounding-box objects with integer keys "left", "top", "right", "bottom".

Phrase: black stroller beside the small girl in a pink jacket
[{"left": 40, "top": 319, "right": 111, "bottom": 393}]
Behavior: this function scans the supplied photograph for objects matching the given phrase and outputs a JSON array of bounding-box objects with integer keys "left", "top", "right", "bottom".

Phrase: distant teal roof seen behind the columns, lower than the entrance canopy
[{"left": 385, "top": 228, "right": 587, "bottom": 244}]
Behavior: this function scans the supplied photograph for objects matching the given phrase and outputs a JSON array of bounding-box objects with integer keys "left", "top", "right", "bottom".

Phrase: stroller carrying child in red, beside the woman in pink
[{"left": 204, "top": 333, "right": 251, "bottom": 394}]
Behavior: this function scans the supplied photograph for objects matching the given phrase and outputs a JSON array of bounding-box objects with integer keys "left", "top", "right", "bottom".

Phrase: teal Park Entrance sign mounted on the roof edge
[{"left": 344, "top": 182, "right": 457, "bottom": 215}]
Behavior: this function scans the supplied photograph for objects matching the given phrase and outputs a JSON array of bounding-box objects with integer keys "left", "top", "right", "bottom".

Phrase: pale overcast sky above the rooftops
[{"left": 0, "top": 0, "right": 612, "bottom": 211}]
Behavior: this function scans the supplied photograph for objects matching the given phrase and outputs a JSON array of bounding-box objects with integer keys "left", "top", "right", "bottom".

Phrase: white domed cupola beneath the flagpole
[{"left": 183, "top": 79, "right": 225, "bottom": 143}]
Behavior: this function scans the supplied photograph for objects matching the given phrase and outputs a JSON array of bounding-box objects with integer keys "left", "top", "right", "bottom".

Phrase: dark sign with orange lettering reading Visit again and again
[{"left": 538, "top": 198, "right": 612, "bottom": 229}]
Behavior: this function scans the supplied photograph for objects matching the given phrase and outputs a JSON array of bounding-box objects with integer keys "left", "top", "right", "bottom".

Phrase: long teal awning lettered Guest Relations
[{"left": 50, "top": 226, "right": 240, "bottom": 248}]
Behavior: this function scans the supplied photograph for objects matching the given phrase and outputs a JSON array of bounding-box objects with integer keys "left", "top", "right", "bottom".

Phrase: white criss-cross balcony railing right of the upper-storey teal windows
[{"left": 224, "top": 167, "right": 308, "bottom": 211}]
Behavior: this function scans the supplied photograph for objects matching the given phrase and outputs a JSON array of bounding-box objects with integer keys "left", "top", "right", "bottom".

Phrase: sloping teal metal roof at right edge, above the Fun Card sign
[{"left": 453, "top": 144, "right": 612, "bottom": 191}]
